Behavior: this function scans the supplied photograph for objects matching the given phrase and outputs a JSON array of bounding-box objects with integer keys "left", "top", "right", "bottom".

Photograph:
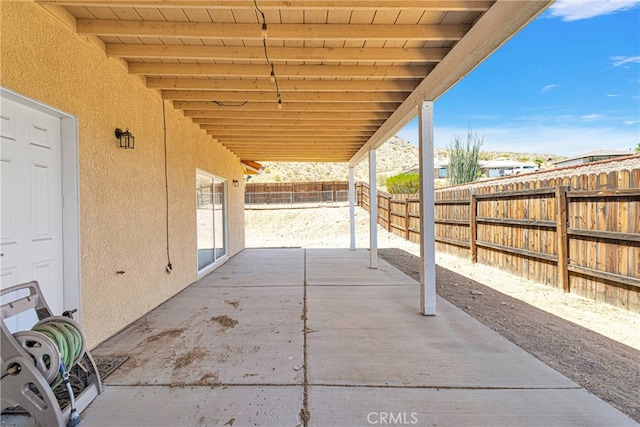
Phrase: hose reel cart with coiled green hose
[{"left": 0, "top": 281, "right": 102, "bottom": 427}]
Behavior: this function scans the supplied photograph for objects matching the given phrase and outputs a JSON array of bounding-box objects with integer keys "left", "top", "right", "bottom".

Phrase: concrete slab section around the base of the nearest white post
[{"left": 307, "top": 286, "right": 578, "bottom": 388}]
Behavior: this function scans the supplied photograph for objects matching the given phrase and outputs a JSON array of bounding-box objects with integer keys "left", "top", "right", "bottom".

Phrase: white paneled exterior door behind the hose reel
[{"left": 0, "top": 98, "right": 64, "bottom": 331}]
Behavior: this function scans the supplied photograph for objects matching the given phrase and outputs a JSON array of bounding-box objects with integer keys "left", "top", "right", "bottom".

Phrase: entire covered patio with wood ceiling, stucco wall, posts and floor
[{"left": 5, "top": 0, "right": 632, "bottom": 426}]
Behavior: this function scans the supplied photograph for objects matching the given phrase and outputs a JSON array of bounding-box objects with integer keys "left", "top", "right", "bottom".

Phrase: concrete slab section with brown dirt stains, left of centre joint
[{"left": 93, "top": 286, "right": 303, "bottom": 386}]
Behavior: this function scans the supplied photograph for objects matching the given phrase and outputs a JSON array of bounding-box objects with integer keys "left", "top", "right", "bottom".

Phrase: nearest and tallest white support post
[{"left": 418, "top": 101, "right": 436, "bottom": 316}]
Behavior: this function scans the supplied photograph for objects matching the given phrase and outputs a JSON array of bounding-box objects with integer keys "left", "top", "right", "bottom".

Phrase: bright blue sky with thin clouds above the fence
[{"left": 398, "top": 0, "right": 640, "bottom": 156}]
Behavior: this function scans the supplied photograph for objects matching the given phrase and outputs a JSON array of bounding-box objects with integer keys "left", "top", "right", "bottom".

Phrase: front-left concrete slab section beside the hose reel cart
[{"left": 81, "top": 386, "right": 302, "bottom": 427}]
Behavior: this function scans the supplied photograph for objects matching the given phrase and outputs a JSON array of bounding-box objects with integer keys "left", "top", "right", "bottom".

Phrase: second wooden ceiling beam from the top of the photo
[{"left": 76, "top": 19, "right": 471, "bottom": 42}]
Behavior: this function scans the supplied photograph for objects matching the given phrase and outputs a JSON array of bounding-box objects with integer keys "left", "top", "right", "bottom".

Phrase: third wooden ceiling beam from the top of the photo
[{"left": 106, "top": 43, "right": 449, "bottom": 65}]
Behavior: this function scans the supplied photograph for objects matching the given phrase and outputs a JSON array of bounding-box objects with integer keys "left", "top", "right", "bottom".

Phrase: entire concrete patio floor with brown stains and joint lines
[{"left": 82, "top": 249, "right": 635, "bottom": 426}]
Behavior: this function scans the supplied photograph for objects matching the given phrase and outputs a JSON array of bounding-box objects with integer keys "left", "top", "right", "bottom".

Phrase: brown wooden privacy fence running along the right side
[{"left": 356, "top": 169, "right": 640, "bottom": 313}]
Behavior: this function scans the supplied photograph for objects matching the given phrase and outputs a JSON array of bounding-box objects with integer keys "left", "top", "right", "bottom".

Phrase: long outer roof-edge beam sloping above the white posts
[{"left": 349, "top": 0, "right": 554, "bottom": 167}]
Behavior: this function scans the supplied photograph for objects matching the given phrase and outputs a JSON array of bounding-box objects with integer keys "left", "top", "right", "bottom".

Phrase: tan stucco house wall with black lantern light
[{"left": 0, "top": 1, "right": 244, "bottom": 347}]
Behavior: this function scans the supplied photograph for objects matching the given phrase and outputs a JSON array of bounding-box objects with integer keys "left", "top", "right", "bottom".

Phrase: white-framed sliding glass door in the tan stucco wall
[{"left": 196, "top": 170, "right": 228, "bottom": 273}]
